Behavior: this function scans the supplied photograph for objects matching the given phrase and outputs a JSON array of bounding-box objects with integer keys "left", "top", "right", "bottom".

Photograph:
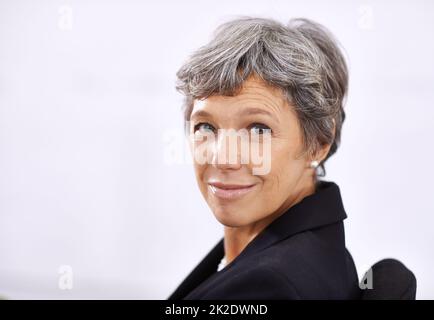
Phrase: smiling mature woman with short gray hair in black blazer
[{"left": 169, "top": 18, "right": 358, "bottom": 299}]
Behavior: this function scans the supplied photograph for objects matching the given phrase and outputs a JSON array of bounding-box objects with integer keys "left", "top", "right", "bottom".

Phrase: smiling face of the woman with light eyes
[{"left": 189, "top": 77, "right": 324, "bottom": 227}]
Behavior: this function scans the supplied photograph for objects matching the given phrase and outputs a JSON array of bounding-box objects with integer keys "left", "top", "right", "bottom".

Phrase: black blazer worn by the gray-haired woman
[{"left": 168, "top": 180, "right": 360, "bottom": 300}]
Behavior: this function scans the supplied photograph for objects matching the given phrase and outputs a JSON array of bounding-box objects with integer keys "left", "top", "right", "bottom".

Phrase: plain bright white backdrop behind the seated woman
[{"left": 0, "top": 0, "right": 434, "bottom": 299}]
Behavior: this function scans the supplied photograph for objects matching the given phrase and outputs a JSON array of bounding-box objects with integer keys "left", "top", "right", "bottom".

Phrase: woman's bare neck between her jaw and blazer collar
[{"left": 224, "top": 178, "right": 315, "bottom": 264}]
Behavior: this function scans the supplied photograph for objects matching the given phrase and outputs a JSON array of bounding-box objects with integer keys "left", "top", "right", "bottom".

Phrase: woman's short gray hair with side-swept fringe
[{"left": 176, "top": 17, "right": 348, "bottom": 176}]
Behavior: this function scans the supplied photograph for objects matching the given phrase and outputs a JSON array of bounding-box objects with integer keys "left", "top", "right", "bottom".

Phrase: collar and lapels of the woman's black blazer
[{"left": 168, "top": 180, "right": 347, "bottom": 300}]
